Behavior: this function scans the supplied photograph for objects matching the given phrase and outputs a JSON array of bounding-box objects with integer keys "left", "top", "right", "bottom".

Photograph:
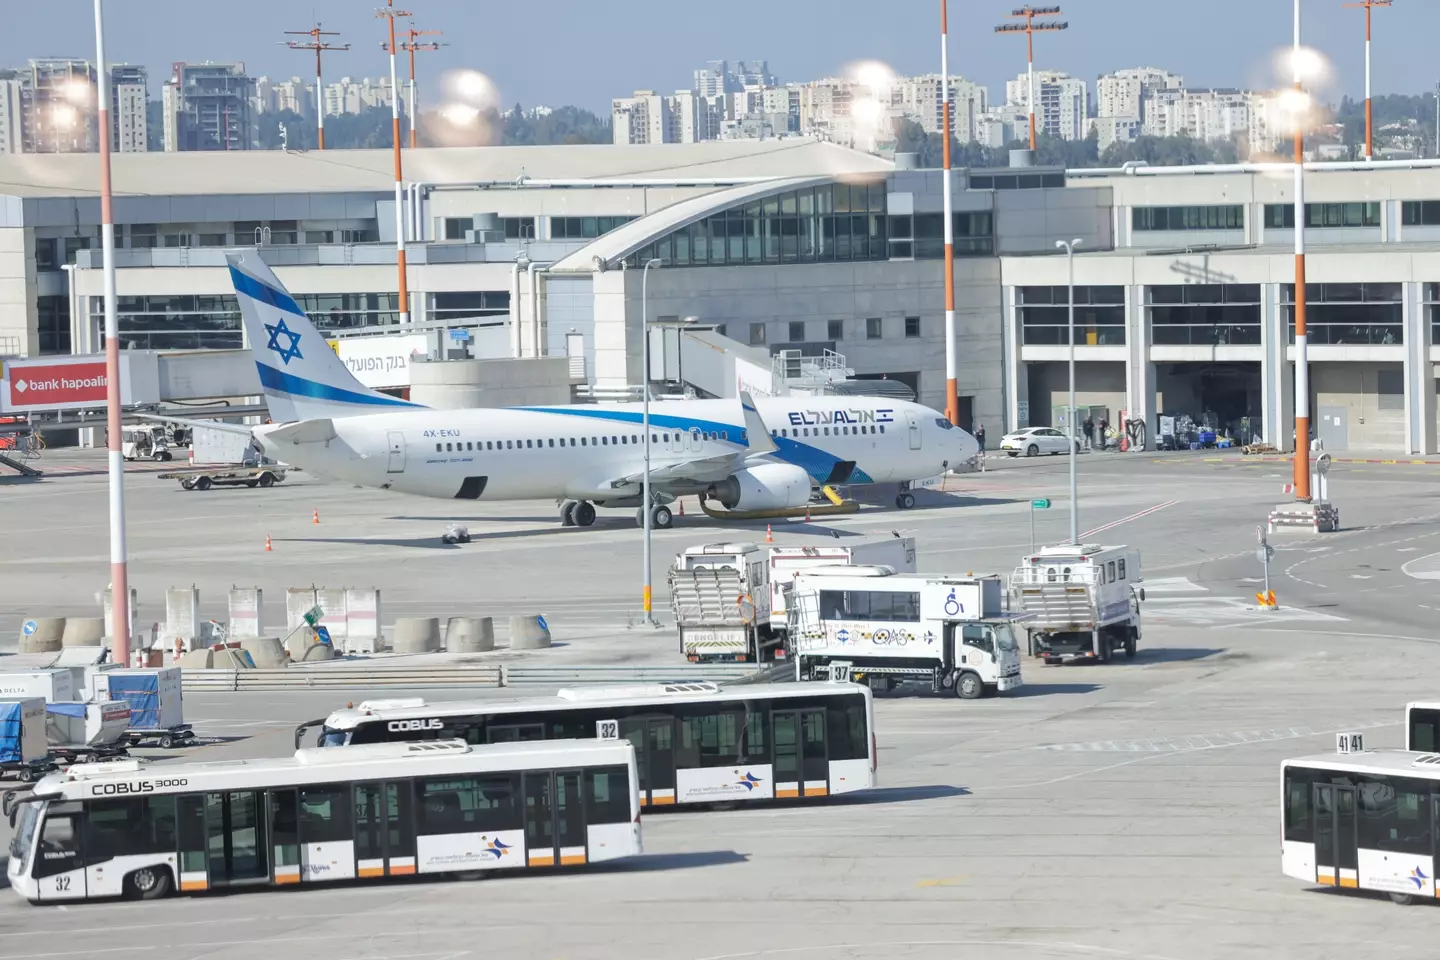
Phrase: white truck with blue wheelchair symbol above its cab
[{"left": 788, "top": 566, "right": 1022, "bottom": 699}]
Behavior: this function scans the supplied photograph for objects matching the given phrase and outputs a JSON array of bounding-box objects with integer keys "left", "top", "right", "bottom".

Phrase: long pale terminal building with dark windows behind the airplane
[{"left": 0, "top": 140, "right": 1440, "bottom": 453}]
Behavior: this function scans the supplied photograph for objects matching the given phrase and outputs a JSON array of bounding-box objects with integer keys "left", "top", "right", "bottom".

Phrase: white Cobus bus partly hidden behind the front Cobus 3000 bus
[{"left": 295, "top": 684, "right": 876, "bottom": 806}]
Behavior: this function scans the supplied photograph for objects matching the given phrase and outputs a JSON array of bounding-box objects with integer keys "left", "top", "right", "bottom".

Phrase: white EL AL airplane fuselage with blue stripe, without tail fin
[{"left": 256, "top": 397, "right": 976, "bottom": 505}]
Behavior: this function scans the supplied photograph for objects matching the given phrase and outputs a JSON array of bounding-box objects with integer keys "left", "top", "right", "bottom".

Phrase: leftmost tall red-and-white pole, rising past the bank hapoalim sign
[{"left": 86, "top": 0, "right": 130, "bottom": 666}]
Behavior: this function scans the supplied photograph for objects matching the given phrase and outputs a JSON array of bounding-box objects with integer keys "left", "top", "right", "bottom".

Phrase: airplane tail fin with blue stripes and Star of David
[{"left": 225, "top": 250, "right": 419, "bottom": 423}]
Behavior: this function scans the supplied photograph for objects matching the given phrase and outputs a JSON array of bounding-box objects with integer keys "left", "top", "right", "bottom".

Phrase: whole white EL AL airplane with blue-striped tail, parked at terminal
[{"left": 226, "top": 250, "right": 979, "bottom": 528}]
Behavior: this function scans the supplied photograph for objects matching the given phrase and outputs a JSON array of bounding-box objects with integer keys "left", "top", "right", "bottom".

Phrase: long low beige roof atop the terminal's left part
[{"left": 0, "top": 138, "right": 893, "bottom": 197}]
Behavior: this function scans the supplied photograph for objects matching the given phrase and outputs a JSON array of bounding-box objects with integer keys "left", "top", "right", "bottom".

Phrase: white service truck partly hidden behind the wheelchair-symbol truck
[{"left": 670, "top": 537, "right": 914, "bottom": 662}]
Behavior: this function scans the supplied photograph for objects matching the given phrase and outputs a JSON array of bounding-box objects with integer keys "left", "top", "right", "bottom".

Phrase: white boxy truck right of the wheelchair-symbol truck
[{"left": 1009, "top": 544, "right": 1145, "bottom": 664}]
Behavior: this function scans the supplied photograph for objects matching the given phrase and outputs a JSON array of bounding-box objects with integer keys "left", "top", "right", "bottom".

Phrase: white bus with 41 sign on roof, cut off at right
[{"left": 1280, "top": 734, "right": 1440, "bottom": 904}]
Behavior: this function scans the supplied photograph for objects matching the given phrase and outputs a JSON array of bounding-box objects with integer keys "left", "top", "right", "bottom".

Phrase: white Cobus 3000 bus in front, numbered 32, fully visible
[{"left": 4, "top": 740, "right": 641, "bottom": 902}]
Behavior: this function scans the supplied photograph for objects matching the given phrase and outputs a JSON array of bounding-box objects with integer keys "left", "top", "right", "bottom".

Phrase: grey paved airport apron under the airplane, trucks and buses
[{"left": 0, "top": 455, "right": 1440, "bottom": 960}]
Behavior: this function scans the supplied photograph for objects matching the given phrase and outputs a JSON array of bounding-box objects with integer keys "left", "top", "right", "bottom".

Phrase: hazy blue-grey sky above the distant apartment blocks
[{"left": 0, "top": 0, "right": 1440, "bottom": 109}]
